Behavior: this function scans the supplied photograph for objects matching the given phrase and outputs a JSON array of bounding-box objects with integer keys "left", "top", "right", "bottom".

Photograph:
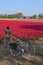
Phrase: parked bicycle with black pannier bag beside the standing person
[{"left": 9, "top": 39, "right": 35, "bottom": 56}]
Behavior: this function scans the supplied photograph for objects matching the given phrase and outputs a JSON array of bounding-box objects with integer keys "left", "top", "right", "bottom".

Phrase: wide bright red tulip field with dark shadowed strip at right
[{"left": 0, "top": 20, "right": 43, "bottom": 38}]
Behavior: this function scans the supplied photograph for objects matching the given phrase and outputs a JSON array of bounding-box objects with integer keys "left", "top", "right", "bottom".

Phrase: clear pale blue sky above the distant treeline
[{"left": 0, "top": 0, "right": 43, "bottom": 16}]
